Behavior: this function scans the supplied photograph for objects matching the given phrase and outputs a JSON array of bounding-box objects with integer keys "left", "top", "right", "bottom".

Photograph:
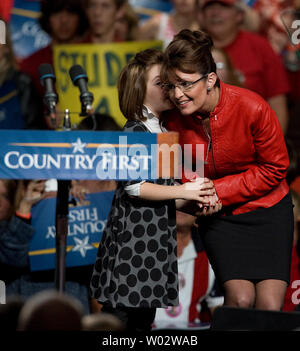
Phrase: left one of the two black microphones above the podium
[{"left": 39, "top": 63, "right": 58, "bottom": 119}]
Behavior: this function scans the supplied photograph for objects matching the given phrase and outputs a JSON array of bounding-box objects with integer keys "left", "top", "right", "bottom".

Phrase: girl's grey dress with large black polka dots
[{"left": 90, "top": 121, "right": 178, "bottom": 308}]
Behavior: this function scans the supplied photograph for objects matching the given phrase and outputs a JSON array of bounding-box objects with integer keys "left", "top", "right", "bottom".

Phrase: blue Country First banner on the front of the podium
[{"left": 0, "top": 130, "right": 158, "bottom": 180}]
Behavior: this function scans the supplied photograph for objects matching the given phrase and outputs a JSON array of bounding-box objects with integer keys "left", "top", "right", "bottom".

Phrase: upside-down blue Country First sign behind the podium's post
[{"left": 29, "top": 191, "right": 114, "bottom": 271}]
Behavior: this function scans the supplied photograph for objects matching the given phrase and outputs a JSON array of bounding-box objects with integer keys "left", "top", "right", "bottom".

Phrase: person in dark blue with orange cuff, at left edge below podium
[{"left": 0, "top": 179, "right": 45, "bottom": 290}]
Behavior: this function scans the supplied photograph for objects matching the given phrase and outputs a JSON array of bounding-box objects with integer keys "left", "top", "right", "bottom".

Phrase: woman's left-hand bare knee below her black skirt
[{"left": 223, "top": 279, "right": 255, "bottom": 308}]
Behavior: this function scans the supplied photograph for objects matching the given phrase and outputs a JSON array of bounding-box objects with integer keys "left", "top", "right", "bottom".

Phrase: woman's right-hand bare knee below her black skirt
[{"left": 255, "top": 279, "right": 287, "bottom": 311}]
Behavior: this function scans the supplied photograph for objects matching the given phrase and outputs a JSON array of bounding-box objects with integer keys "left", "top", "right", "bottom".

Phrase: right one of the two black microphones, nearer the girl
[{"left": 69, "top": 65, "right": 94, "bottom": 116}]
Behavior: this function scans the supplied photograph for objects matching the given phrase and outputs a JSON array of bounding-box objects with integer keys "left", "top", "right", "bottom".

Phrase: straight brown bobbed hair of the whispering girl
[{"left": 118, "top": 49, "right": 163, "bottom": 120}]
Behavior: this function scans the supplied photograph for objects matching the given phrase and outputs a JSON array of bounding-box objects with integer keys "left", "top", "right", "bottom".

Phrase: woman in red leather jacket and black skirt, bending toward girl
[{"left": 162, "top": 30, "right": 293, "bottom": 310}]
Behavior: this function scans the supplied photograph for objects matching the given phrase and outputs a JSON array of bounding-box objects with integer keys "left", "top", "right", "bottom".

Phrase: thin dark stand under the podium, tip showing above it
[{"left": 55, "top": 109, "right": 71, "bottom": 293}]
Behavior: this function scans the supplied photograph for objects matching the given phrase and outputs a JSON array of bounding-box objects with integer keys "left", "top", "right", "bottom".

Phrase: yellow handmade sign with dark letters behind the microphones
[{"left": 54, "top": 41, "right": 162, "bottom": 127}]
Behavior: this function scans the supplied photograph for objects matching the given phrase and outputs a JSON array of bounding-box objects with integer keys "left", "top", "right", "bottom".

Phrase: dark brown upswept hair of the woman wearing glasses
[{"left": 161, "top": 29, "right": 220, "bottom": 85}]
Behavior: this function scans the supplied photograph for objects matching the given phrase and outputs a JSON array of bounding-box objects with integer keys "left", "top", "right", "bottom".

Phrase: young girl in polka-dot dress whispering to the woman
[{"left": 90, "top": 49, "right": 217, "bottom": 331}]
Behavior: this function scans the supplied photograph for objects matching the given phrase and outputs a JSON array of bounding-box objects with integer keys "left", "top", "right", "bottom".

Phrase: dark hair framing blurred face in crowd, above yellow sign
[{"left": 39, "top": 0, "right": 88, "bottom": 35}]
